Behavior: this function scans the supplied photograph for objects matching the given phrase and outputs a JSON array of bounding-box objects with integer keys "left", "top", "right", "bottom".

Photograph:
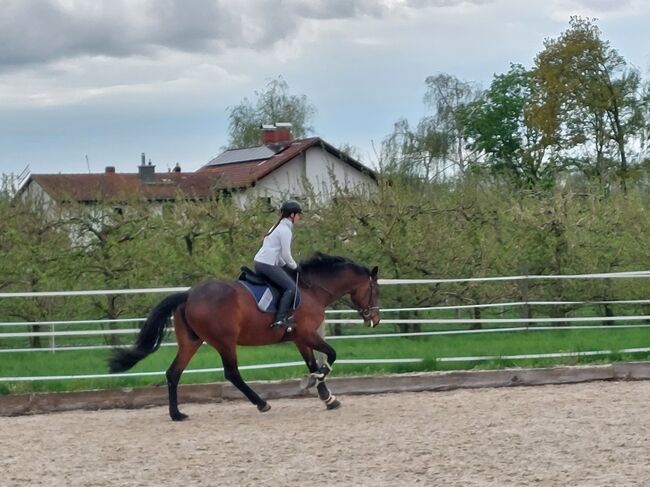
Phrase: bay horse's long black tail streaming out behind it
[{"left": 108, "top": 291, "right": 189, "bottom": 373}]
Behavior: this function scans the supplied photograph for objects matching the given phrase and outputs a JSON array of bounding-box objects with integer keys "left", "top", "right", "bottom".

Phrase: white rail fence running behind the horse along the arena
[{"left": 0, "top": 271, "right": 650, "bottom": 382}]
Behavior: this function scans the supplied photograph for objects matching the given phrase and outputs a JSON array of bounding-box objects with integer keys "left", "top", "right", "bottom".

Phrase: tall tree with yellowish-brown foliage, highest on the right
[{"left": 531, "top": 17, "right": 643, "bottom": 190}]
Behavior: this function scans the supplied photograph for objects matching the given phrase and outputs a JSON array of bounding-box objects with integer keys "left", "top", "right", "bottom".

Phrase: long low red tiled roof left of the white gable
[{"left": 24, "top": 173, "right": 224, "bottom": 202}]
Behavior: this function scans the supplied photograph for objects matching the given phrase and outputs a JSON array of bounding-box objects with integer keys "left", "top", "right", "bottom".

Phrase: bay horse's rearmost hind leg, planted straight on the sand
[{"left": 166, "top": 309, "right": 203, "bottom": 421}]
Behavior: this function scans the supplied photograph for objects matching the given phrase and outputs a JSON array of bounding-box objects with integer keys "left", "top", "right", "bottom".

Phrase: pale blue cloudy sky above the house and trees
[{"left": 0, "top": 0, "right": 650, "bottom": 179}]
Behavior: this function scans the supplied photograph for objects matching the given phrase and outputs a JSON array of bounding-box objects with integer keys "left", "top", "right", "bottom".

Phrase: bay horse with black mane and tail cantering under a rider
[{"left": 109, "top": 253, "right": 380, "bottom": 421}]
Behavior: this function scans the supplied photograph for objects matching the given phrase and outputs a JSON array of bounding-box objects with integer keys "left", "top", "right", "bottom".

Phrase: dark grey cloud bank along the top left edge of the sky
[{"left": 0, "top": 0, "right": 485, "bottom": 70}]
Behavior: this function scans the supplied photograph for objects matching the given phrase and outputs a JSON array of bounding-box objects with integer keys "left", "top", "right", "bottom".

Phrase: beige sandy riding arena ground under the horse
[{"left": 0, "top": 381, "right": 650, "bottom": 487}]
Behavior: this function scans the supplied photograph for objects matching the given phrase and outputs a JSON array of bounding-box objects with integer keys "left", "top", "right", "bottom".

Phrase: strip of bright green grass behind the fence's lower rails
[{"left": 0, "top": 325, "right": 650, "bottom": 394}]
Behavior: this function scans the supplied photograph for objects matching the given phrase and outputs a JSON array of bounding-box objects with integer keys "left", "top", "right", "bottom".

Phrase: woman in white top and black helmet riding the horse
[{"left": 254, "top": 200, "right": 302, "bottom": 331}]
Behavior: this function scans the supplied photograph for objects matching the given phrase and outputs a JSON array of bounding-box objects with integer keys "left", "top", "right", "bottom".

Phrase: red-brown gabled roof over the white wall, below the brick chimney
[{"left": 198, "top": 137, "right": 375, "bottom": 188}]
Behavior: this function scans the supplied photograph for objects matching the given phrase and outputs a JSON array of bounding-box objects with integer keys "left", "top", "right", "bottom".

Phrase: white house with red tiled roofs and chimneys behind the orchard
[{"left": 18, "top": 123, "right": 377, "bottom": 208}]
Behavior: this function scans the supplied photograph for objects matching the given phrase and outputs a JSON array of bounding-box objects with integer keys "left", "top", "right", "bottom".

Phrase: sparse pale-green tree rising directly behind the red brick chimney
[{"left": 227, "top": 76, "right": 316, "bottom": 148}]
